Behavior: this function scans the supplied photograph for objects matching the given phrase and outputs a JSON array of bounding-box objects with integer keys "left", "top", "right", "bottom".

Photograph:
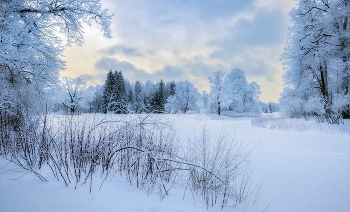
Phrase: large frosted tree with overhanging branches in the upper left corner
[{"left": 0, "top": 0, "right": 111, "bottom": 119}]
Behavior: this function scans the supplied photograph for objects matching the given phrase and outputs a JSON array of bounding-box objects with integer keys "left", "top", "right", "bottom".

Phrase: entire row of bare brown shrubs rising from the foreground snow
[{"left": 0, "top": 115, "right": 258, "bottom": 207}]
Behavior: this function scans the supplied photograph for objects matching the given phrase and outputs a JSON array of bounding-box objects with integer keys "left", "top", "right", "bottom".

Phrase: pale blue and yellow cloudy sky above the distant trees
[{"left": 62, "top": 0, "right": 295, "bottom": 102}]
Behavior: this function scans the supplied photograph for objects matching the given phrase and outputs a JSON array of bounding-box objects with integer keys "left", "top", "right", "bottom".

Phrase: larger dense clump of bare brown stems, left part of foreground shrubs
[{"left": 0, "top": 115, "right": 176, "bottom": 192}]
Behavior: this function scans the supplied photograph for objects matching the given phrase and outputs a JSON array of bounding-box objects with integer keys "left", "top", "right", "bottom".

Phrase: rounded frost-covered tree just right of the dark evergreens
[{"left": 165, "top": 80, "right": 200, "bottom": 113}]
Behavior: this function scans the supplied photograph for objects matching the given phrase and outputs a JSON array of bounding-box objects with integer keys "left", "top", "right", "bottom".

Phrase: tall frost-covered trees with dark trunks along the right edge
[{"left": 280, "top": 0, "right": 350, "bottom": 123}]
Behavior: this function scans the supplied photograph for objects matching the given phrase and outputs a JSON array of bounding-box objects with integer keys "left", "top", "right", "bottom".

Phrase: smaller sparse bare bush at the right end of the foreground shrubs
[{"left": 185, "top": 126, "right": 259, "bottom": 208}]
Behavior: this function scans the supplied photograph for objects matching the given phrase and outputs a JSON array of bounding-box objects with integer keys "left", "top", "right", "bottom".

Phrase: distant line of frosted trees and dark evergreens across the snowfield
[{"left": 52, "top": 68, "right": 270, "bottom": 115}]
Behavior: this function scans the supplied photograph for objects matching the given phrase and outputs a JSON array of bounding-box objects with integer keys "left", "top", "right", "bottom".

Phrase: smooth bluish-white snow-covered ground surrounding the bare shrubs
[{"left": 0, "top": 114, "right": 350, "bottom": 212}]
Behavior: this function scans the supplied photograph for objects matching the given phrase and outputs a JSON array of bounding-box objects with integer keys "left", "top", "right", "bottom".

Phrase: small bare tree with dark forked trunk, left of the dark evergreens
[{"left": 62, "top": 77, "right": 86, "bottom": 114}]
